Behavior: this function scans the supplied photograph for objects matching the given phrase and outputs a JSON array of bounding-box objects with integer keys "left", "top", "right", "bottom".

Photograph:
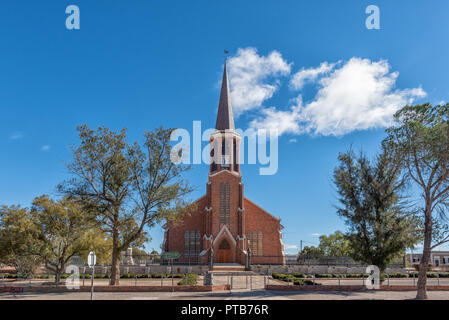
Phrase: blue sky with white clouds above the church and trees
[{"left": 0, "top": 0, "right": 449, "bottom": 252}]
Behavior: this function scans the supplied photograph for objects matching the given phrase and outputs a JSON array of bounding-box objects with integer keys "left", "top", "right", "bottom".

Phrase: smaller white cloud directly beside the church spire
[{"left": 228, "top": 48, "right": 291, "bottom": 116}]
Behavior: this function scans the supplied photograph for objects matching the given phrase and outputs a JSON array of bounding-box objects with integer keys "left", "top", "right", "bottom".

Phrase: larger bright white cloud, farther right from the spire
[{"left": 250, "top": 58, "right": 426, "bottom": 136}]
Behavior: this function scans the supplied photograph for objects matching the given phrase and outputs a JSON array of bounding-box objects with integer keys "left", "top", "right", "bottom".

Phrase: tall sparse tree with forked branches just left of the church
[{"left": 59, "top": 125, "right": 191, "bottom": 285}]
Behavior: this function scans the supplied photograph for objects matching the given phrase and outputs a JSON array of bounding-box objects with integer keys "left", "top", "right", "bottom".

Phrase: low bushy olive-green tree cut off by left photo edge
[{"left": 0, "top": 206, "right": 43, "bottom": 277}]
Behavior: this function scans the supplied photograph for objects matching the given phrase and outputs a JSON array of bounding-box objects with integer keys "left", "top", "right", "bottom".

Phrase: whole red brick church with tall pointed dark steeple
[{"left": 163, "top": 62, "right": 285, "bottom": 265}]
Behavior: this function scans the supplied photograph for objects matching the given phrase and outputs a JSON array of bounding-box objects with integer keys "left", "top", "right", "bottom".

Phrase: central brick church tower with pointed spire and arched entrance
[{"left": 205, "top": 61, "right": 246, "bottom": 263}]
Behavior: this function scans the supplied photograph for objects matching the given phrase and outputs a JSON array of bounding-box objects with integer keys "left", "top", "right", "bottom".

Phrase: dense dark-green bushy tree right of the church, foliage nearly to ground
[{"left": 334, "top": 150, "right": 418, "bottom": 272}]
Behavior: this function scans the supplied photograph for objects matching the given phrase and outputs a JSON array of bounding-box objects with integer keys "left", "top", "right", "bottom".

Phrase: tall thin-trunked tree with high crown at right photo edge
[{"left": 383, "top": 103, "right": 449, "bottom": 299}]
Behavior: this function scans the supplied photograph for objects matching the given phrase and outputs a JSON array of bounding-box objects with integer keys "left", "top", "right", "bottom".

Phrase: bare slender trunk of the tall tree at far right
[{"left": 416, "top": 203, "right": 432, "bottom": 299}]
